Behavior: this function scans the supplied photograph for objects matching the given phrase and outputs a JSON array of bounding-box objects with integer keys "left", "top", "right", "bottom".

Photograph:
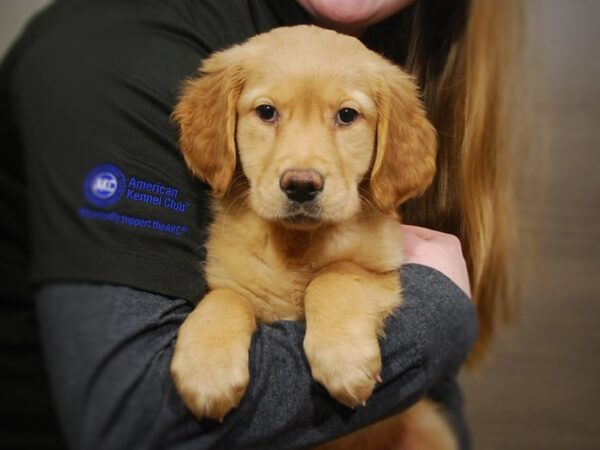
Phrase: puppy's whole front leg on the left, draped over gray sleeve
[{"left": 171, "top": 289, "right": 256, "bottom": 420}]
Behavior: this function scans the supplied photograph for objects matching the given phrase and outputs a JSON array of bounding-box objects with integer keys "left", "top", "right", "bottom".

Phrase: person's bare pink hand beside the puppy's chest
[{"left": 401, "top": 225, "right": 471, "bottom": 297}]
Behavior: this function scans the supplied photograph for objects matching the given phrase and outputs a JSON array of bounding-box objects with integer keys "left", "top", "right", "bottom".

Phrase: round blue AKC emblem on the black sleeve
[{"left": 83, "top": 164, "right": 127, "bottom": 208}]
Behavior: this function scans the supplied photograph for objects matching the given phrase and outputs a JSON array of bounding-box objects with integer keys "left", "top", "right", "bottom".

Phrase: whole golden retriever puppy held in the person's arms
[{"left": 171, "top": 26, "right": 454, "bottom": 450}]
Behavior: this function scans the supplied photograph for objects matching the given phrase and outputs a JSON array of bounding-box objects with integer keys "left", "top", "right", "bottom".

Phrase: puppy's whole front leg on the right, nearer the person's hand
[{"left": 304, "top": 262, "right": 400, "bottom": 407}]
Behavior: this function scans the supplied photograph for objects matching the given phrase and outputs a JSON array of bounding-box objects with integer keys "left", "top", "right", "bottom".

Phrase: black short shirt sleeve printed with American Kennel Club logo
[{"left": 9, "top": 0, "right": 284, "bottom": 301}]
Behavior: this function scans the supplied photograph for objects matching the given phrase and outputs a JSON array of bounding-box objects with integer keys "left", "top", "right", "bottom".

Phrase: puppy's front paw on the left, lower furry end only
[{"left": 171, "top": 340, "right": 250, "bottom": 421}]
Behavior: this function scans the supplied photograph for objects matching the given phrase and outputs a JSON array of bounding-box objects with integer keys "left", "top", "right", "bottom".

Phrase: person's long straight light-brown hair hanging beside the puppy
[{"left": 402, "top": 0, "right": 522, "bottom": 362}]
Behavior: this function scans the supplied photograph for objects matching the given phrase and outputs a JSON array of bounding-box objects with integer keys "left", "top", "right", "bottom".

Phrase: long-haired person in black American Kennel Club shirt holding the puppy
[{"left": 0, "top": 0, "right": 509, "bottom": 449}]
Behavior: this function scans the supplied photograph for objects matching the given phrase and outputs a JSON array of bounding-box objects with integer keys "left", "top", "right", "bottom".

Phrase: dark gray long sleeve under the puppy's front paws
[{"left": 36, "top": 264, "right": 477, "bottom": 450}]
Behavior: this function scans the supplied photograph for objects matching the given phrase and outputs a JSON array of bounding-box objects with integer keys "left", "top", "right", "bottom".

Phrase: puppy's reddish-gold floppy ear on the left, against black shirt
[{"left": 173, "top": 47, "right": 244, "bottom": 198}]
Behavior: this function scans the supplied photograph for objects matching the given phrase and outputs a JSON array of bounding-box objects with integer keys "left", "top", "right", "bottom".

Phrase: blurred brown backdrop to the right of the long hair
[{"left": 463, "top": 0, "right": 600, "bottom": 450}]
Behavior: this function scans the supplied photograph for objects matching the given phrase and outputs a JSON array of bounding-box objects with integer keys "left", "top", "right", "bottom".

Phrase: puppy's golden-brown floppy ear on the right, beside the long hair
[{"left": 370, "top": 63, "right": 437, "bottom": 213}]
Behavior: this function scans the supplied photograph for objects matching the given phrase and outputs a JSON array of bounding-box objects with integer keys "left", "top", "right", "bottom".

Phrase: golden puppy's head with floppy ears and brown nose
[{"left": 174, "top": 26, "right": 436, "bottom": 227}]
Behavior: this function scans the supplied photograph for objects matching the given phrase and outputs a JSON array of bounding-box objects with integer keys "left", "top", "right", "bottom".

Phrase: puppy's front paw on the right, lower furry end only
[{"left": 304, "top": 329, "right": 381, "bottom": 408}]
